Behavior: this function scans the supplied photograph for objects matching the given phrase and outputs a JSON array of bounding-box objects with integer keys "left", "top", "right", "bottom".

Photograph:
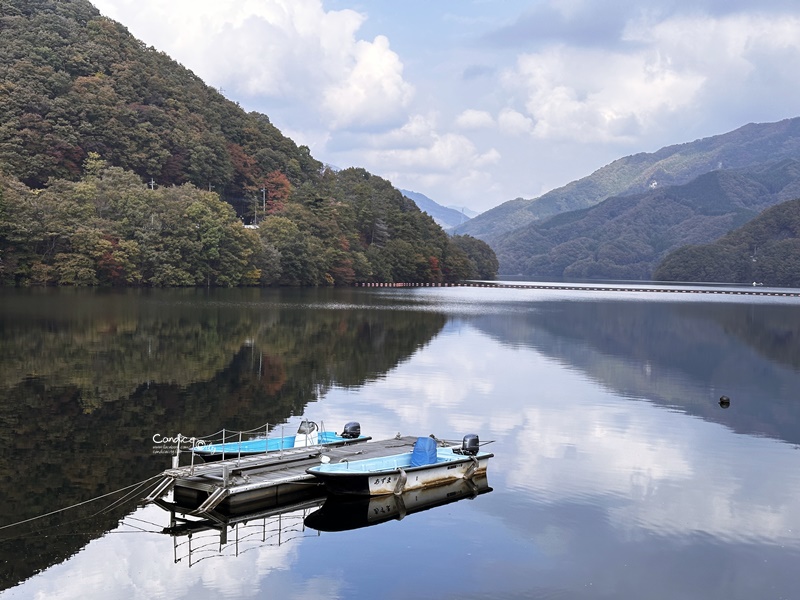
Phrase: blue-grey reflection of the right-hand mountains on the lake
[{"left": 466, "top": 299, "right": 800, "bottom": 443}]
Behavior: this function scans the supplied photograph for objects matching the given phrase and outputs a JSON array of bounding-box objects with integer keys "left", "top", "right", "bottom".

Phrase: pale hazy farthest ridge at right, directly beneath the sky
[{"left": 454, "top": 118, "right": 800, "bottom": 247}]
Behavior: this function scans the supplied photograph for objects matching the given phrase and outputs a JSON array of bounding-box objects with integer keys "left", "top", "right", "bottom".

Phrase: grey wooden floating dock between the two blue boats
[{"left": 144, "top": 436, "right": 417, "bottom": 517}]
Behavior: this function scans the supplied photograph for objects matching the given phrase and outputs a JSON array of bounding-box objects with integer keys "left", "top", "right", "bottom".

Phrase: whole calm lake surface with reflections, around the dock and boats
[{"left": 0, "top": 288, "right": 800, "bottom": 600}]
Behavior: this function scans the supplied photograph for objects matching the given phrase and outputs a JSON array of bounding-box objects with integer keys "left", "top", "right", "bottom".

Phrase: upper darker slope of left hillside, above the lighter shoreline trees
[{"left": 0, "top": 0, "right": 322, "bottom": 200}]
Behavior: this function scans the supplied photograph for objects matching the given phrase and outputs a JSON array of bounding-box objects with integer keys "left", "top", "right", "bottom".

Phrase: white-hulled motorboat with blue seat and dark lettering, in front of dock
[{"left": 306, "top": 434, "right": 494, "bottom": 496}]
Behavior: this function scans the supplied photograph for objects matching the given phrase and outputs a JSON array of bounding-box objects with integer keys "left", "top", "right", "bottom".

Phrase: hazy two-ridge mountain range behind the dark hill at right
[{"left": 454, "top": 118, "right": 800, "bottom": 279}]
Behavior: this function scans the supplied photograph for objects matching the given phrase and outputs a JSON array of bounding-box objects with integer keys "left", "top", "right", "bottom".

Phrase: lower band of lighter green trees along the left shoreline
[{"left": 0, "top": 159, "right": 497, "bottom": 287}]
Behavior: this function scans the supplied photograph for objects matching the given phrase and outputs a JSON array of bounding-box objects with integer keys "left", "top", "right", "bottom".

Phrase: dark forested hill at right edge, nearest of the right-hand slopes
[{"left": 653, "top": 199, "right": 800, "bottom": 287}]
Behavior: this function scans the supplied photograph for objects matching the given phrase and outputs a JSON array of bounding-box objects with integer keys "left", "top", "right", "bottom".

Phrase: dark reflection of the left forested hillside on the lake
[{"left": 0, "top": 290, "right": 445, "bottom": 586}]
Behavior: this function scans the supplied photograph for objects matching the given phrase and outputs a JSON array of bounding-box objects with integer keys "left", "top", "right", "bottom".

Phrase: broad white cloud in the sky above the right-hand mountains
[{"left": 504, "top": 14, "right": 800, "bottom": 142}]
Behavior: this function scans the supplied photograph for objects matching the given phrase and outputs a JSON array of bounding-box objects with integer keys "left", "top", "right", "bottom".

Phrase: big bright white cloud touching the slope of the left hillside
[{"left": 96, "top": 0, "right": 413, "bottom": 128}]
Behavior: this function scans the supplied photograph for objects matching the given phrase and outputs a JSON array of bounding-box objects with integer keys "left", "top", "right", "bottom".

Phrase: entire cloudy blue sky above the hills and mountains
[{"left": 93, "top": 0, "right": 800, "bottom": 212}]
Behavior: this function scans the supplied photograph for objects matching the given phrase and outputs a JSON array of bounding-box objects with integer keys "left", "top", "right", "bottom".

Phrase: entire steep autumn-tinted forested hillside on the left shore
[{"left": 0, "top": 0, "right": 496, "bottom": 286}]
